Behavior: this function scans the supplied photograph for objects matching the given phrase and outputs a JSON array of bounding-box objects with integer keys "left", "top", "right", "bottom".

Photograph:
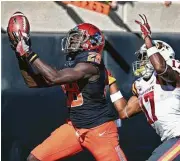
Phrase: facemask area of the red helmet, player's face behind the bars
[{"left": 61, "top": 30, "right": 89, "bottom": 53}]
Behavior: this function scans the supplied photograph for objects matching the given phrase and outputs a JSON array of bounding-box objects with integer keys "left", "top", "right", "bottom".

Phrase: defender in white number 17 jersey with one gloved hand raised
[{"left": 107, "top": 15, "right": 180, "bottom": 161}]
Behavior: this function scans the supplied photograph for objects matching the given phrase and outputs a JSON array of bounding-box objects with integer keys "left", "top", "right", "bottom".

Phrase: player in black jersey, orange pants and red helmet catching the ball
[{"left": 8, "top": 13, "right": 126, "bottom": 161}]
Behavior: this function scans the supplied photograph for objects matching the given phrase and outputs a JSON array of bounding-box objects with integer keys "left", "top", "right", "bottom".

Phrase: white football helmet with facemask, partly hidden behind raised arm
[{"left": 132, "top": 40, "right": 175, "bottom": 79}]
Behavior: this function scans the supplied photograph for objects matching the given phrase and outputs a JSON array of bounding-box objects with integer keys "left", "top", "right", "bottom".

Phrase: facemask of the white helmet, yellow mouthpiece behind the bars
[{"left": 132, "top": 50, "right": 154, "bottom": 79}]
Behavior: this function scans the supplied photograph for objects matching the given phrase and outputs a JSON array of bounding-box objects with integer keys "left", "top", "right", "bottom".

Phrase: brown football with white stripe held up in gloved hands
[{"left": 7, "top": 12, "right": 30, "bottom": 41}]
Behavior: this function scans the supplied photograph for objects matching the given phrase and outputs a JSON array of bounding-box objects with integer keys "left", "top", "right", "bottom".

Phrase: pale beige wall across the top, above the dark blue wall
[{"left": 1, "top": 1, "right": 180, "bottom": 32}]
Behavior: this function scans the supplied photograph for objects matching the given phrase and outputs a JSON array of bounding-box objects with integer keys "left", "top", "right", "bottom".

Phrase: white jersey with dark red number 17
[{"left": 133, "top": 60, "right": 180, "bottom": 141}]
